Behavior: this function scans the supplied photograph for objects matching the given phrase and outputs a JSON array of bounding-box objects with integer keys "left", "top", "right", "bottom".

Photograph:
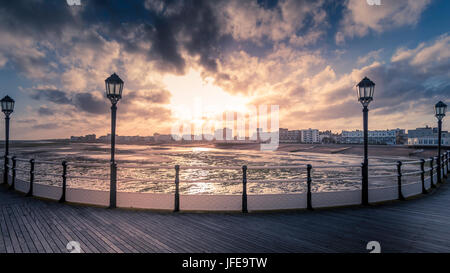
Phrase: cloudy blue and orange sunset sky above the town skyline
[{"left": 0, "top": 0, "right": 450, "bottom": 139}]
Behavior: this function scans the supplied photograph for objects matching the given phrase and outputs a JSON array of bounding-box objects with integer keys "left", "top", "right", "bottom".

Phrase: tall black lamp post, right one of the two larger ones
[{"left": 356, "top": 77, "right": 375, "bottom": 205}]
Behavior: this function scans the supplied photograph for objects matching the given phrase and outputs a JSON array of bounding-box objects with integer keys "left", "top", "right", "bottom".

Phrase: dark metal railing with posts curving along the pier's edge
[{"left": 0, "top": 151, "right": 450, "bottom": 213}]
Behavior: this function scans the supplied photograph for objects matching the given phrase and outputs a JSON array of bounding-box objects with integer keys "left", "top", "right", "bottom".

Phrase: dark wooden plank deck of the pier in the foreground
[{"left": 0, "top": 182, "right": 450, "bottom": 253}]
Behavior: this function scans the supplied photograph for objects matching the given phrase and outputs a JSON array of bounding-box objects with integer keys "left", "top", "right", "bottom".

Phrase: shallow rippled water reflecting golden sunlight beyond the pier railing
[{"left": 1, "top": 143, "right": 419, "bottom": 194}]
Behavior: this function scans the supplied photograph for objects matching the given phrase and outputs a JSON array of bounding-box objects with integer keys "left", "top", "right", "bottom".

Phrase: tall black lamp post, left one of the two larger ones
[{"left": 105, "top": 73, "right": 123, "bottom": 208}]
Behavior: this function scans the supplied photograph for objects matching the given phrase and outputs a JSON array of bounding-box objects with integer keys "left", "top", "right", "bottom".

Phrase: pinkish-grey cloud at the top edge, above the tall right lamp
[{"left": 335, "top": 0, "right": 431, "bottom": 44}]
